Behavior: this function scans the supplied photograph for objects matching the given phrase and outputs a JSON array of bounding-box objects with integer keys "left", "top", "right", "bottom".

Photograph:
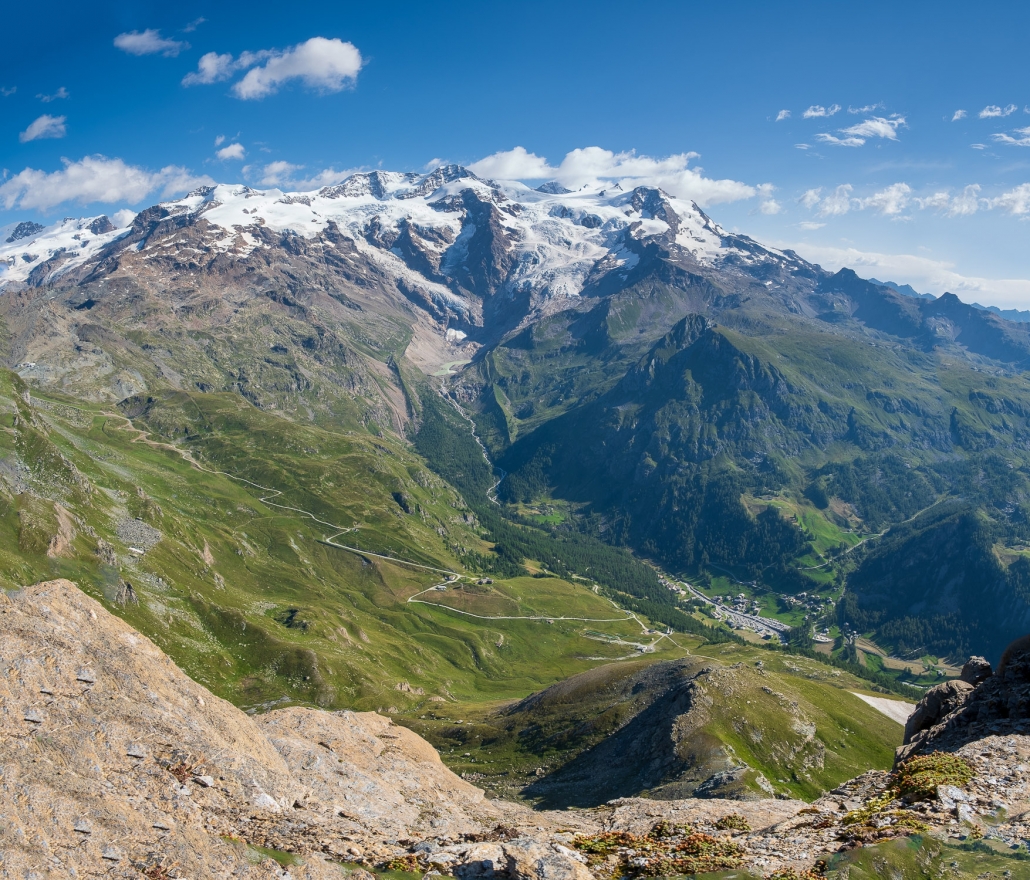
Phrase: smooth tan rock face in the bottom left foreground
[{"left": 0, "top": 580, "right": 501, "bottom": 878}]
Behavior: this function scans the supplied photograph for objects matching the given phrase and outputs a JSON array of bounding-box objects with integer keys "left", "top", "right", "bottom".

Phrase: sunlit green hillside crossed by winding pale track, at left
[{"left": 0, "top": 373, "right": 672, "bottom": 712}]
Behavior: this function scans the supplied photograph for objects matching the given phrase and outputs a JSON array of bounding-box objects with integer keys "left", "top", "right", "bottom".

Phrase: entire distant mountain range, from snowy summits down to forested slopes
[{"left": 0, "top": 165, "right": 1030, "bottom": 652}]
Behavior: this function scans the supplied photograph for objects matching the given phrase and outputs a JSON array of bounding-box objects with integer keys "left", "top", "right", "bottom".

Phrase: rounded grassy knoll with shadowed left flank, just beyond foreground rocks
[{"left": 412, "top": 637, "right": 902, "bottom": 808}]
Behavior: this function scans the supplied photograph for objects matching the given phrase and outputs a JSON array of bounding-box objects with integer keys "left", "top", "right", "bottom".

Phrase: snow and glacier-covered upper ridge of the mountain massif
[{"left": 0, "top": 165, "right": 812, "bottom": 331}]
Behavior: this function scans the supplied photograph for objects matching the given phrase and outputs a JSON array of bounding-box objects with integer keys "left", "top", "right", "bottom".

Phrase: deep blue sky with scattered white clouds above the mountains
[{"left": 0, "top": 0, "right": 1030, "bottom": 308}]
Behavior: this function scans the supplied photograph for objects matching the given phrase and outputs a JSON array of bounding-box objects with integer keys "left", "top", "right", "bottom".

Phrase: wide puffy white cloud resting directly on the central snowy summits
[{"left": 469, "top": 146, "right": 758, "bottom": 205}]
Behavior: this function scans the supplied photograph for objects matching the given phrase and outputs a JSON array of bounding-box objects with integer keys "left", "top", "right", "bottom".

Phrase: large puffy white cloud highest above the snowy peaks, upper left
[{"left": 233, "top": 37, "right": 364, "bottom": 100}]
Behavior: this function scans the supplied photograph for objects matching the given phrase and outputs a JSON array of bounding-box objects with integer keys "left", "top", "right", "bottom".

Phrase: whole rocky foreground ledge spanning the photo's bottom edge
[{"left": 0, "top": 580, "right": 1030, "bottom": 880}]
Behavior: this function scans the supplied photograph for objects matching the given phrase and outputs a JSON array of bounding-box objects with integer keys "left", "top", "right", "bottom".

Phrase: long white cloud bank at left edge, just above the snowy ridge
[{"left": 0, "top": 156, "right": 214, "bottom": 210}]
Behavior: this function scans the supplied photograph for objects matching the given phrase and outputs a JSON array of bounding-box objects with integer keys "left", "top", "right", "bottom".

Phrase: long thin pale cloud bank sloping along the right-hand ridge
[{"left": 776, "top": 241, "right": 1030, "bottom": 308}]
